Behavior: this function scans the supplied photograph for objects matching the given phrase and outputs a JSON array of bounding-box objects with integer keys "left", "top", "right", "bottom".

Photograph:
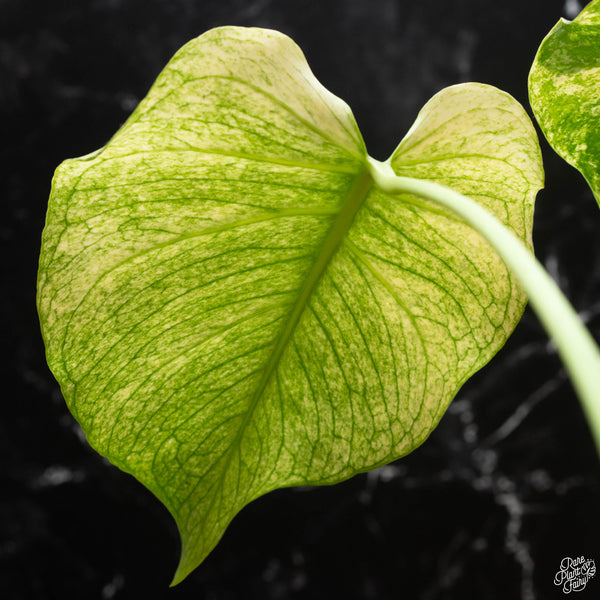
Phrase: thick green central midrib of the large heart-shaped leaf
[{"left": 223, "top": 167, "right": 373, "bottom": 475}]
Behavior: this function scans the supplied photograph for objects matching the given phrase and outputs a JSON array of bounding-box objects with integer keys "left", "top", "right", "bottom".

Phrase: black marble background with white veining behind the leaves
[{"left": 0, "top": 0, "right": 600, "bottom": 600}]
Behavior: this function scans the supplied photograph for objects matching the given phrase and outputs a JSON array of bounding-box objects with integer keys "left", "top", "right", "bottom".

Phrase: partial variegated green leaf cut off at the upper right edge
[{"left": 529, "top": 0, "right": 600, "bottom": 203}]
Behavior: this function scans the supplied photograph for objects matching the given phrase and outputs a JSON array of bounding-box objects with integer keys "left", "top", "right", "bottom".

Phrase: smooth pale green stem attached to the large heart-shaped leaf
[{"left": 369, "top": 158, "right": 600, "bottom": 454}]
